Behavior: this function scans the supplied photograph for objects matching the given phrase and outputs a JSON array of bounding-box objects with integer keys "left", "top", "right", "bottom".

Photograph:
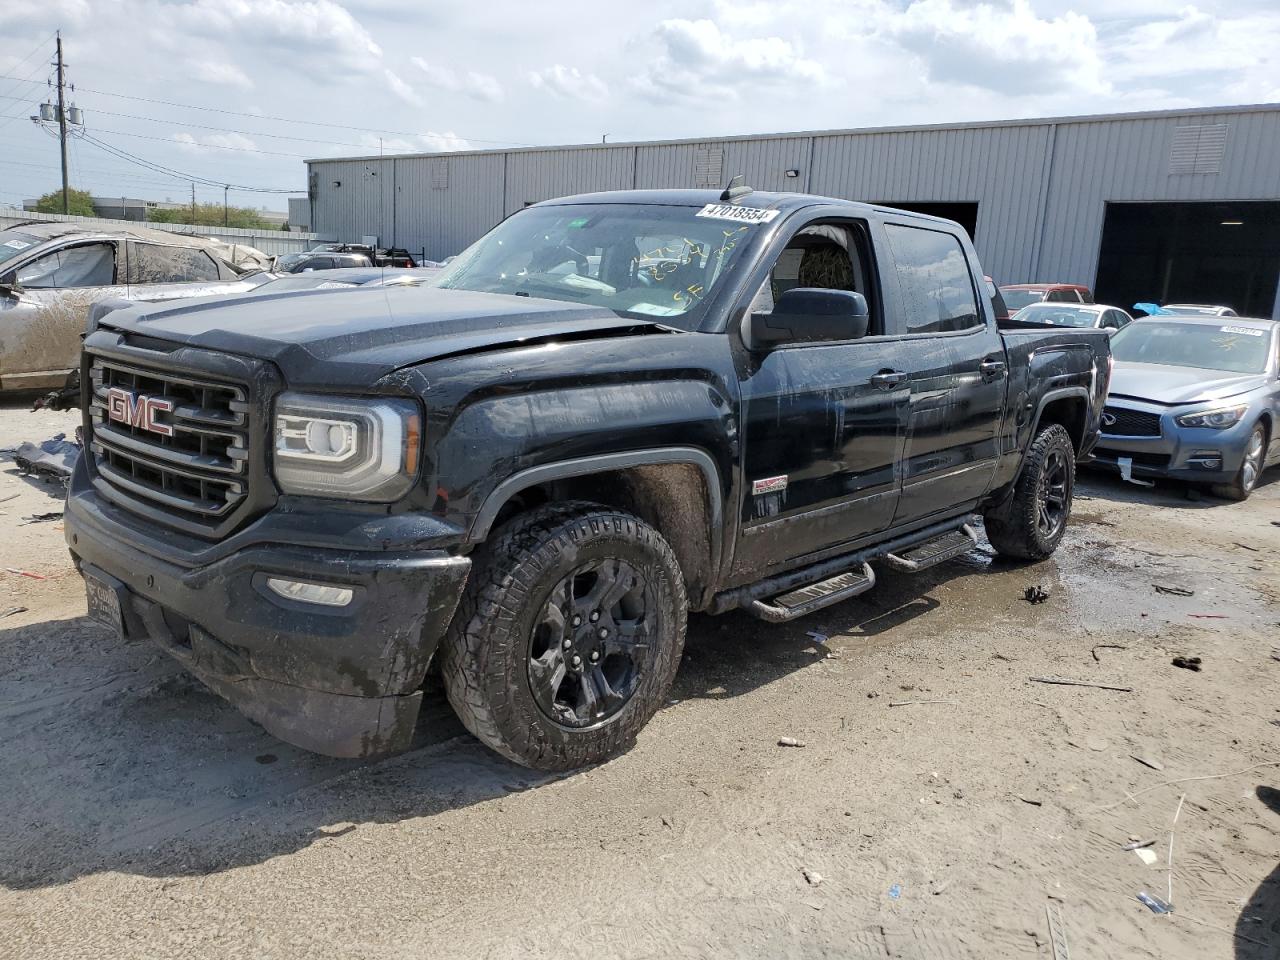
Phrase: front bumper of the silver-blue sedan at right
[{"left": 1093, "top": 399, "right": 1254, "bottom": 484}]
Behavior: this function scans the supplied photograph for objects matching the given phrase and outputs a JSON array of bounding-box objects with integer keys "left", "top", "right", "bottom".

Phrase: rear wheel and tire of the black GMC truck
[{"left": 983, "top": 424, "right": 1075, "bottom": 559}]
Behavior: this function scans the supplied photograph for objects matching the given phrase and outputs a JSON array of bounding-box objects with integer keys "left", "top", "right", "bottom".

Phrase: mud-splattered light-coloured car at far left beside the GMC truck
[{"left": 0, "top": 223, "right": 262, "bottom": 390}]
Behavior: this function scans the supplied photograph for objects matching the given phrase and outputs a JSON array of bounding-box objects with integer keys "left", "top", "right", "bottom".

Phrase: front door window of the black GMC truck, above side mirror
[{"left": 751, "top": 223, "right": 884, "bottom": 337}]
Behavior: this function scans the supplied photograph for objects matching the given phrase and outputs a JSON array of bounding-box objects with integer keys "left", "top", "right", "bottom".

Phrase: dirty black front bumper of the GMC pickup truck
[{"left": 65, "top": 457, "right": 470, "bottom": 756}]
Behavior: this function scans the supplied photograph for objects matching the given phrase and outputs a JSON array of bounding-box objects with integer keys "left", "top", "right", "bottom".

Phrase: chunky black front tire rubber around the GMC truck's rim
[{"left": 440, "top": 500, "right": 689, "bottom": 771}]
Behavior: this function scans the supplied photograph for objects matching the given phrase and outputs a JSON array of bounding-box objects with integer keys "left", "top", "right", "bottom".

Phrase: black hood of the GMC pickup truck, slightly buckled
[{"left": 101, "top": 287, "right": 672, "bottom": 385}]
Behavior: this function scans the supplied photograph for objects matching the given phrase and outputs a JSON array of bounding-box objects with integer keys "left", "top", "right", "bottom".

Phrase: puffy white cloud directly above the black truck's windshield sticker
[{"left": 639, "top": 19, "right": 827, "bottom": 100}]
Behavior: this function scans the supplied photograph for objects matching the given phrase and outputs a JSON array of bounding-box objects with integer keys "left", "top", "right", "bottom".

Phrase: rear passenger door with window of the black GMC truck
[{"left": 883, "top": 216, "right": 1009, "bottom": 526}]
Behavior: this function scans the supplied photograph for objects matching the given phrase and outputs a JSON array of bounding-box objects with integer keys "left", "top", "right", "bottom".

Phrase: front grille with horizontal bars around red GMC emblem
[{"left": 90, "top": 357, "right": 250, "bottom": 531}]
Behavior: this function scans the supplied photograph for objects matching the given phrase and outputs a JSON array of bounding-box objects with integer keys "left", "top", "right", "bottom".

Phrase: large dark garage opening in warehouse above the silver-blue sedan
[{"left": 1094, "top": 201, "right": 1280, "bottom": 317}]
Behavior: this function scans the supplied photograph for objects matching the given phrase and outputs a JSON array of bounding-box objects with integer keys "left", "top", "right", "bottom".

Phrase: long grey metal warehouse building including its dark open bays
[{"left": 307, "top": 104, "right": 1280, "bottom": 317}]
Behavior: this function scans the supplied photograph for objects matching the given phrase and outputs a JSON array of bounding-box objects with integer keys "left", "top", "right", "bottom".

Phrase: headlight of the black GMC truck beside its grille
[{"left": 275, "top": 393, "right": 421, "bottom": 503}]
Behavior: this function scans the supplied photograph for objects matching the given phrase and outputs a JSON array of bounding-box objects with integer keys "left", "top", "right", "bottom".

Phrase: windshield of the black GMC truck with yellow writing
[{"left": 433, "top": 204, "right": 777, "bottom": 330}]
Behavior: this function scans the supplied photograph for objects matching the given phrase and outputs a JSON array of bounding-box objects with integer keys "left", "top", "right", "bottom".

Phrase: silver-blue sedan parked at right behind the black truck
[{"left": 1096, "top": 316, "right": 1280, "bottom": 500}]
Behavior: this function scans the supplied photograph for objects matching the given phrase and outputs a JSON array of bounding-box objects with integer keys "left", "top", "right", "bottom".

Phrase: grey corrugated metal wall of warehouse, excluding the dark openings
[{"left": 304, "top": 108, "right": 1280, "bottom": 284}]
